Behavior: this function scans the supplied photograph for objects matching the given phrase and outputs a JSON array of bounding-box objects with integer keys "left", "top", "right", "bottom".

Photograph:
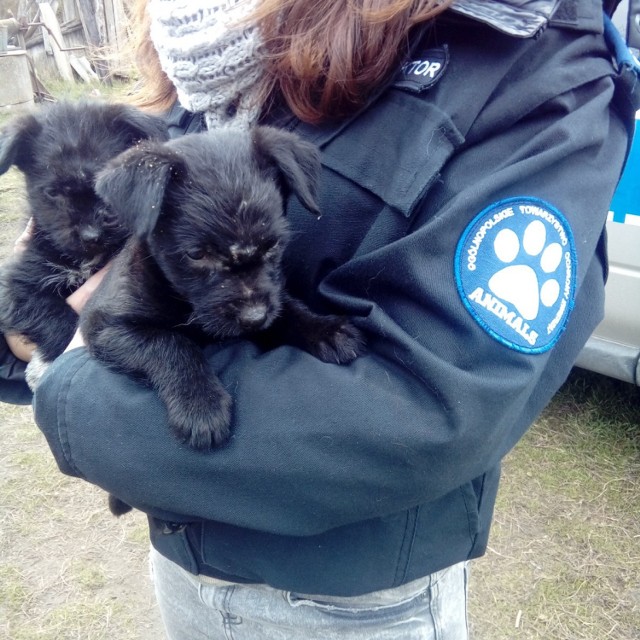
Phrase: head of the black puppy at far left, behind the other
[{"left": 0, "top": 101, "right": 168, "bottom": 261}]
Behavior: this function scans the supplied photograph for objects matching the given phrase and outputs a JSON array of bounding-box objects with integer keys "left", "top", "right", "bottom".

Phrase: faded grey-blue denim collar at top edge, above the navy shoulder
[{"left": 451, "top": 0, "right": 562, "bottom": 38}]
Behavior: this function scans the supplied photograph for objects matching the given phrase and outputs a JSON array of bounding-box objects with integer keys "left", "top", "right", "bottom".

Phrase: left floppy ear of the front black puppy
[{"left": 95, "top": 142, "right": 184, "bottom": 238}]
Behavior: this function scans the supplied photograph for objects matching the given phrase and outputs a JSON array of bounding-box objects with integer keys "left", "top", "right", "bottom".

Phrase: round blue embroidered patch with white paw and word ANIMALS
[{"left": 455, "top": 197, "right": 576, "bottom": 353}]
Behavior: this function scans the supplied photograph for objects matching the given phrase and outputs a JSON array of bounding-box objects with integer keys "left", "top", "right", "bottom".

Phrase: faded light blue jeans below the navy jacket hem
[{"left": 151, "top": 549, "right": 468, "bottom": 640}]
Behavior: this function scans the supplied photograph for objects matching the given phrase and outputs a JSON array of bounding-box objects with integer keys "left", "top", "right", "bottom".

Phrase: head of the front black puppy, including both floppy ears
[{"left": 96, "top": 127, "right": 320, "bottom": 337}]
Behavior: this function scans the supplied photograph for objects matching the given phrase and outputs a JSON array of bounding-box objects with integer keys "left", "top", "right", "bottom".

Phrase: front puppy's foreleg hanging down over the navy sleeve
[{"left": 84, "top": 316, "right": 231, "bottom": 449}]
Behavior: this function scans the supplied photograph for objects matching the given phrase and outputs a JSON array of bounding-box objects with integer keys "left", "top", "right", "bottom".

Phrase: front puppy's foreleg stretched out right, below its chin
[{"left": 267, "top": 293, "right": 365, "bottom": 364}]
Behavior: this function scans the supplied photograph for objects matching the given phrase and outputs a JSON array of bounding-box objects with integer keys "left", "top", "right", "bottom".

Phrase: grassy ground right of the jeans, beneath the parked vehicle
[{"left": 472, "top": 371, "right": 640, "bottom": 640}]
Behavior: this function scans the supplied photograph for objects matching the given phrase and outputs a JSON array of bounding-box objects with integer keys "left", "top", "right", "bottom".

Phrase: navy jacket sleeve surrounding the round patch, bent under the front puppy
[{"left": 35, "top": 41, "right": 627, "bottom": 535}]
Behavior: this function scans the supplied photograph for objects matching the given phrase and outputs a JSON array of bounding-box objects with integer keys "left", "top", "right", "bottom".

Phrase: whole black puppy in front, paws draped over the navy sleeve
[{"left": 80, "top": 127, "right": 362, "bottom": 456}]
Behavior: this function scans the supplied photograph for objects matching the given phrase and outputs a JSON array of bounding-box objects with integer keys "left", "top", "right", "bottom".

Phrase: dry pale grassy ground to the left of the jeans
[{"left": 0, "top": 405, "right": 162, "bottom": 640}]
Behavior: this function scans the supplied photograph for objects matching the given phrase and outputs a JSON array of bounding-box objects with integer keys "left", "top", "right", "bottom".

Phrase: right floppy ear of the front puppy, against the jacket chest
[{"left": 253, "top": 127, "right": 321, "bottom": 216}]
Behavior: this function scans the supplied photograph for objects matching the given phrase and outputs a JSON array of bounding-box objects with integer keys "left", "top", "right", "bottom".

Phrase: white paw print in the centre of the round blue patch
[{"left": 488, "top": 220, "right": 562, "bottom": 320}]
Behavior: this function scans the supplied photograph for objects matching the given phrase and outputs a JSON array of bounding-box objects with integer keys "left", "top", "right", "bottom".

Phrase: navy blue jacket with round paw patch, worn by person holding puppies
[{"left": 8, "top": 0, "right": 634, "bottom": 595}]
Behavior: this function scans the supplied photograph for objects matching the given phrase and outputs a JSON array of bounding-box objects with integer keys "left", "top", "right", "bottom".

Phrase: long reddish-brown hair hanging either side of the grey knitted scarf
[{"left": 127, "top": 0, "right": 453, "bottom": 122}]
